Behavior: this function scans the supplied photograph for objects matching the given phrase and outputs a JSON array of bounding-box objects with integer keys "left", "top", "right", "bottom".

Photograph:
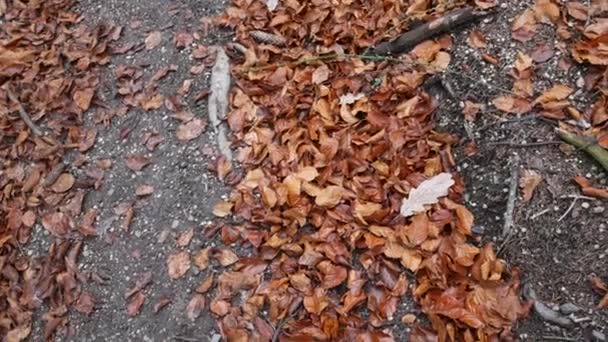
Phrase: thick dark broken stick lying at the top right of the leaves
[{"left": 369, "top": 7, "right": 489, "bottom": 55}]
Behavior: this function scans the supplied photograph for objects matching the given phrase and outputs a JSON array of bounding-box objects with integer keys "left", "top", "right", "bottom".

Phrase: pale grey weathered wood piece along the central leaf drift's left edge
[{"left": 208, "top": 47, "right": 232, "bottom": 162}]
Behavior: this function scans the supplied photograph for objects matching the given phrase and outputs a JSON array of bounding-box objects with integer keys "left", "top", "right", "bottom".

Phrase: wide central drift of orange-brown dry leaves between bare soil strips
[{"left": 194, "top": 0, "right": 528, "bottom": 341}]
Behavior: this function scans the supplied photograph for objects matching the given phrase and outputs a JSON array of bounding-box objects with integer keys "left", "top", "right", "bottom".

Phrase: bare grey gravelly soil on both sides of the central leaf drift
[{"left": 8, "top": 0, "right": 608, "bottom": 341}]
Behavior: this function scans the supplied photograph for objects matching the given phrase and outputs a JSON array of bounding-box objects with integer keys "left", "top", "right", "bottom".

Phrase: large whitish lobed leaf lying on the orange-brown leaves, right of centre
[{"left": 401, "top": 173, "right": 455, "bottom": 217}]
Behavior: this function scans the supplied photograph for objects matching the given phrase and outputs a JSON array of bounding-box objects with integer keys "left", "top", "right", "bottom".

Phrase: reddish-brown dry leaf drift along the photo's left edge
[{"left": 0, "top": 0, "right": 120, "bottom": 341}]
